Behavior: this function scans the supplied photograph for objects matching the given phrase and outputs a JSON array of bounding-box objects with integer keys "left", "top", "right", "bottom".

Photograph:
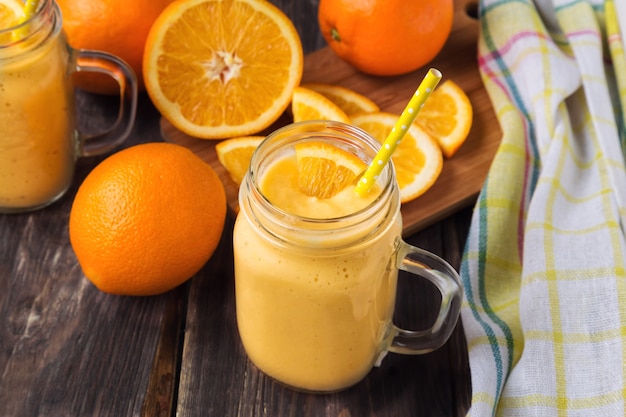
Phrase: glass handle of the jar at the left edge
[{"left": 75, "top": 49, "right": 138, "bottom": 156}]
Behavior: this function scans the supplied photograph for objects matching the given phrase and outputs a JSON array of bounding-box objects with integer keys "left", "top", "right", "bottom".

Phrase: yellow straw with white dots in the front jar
[{"left": 355, "top": 68, "right": 441, "bottom": 196}]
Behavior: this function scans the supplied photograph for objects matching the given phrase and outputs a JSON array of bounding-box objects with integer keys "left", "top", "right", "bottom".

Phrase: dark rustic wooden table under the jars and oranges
[{"left": 0, "top": 0, "right": 471, "bottom": 417}]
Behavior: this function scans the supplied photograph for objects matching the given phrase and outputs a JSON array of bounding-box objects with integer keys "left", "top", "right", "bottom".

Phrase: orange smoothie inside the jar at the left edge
[{"left": 0, "top": 27, "right": 77, "bottom": 210}]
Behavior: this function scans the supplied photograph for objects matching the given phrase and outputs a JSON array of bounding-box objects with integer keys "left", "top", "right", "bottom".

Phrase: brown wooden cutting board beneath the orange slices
[{"left": 161, "top": 0, "right": 501, "bottom": 236}]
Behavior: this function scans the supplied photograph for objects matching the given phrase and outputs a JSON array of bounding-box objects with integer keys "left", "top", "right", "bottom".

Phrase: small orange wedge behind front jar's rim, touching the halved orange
[{"left": 291, "top": 87, "right": 350, "bottom": 123}]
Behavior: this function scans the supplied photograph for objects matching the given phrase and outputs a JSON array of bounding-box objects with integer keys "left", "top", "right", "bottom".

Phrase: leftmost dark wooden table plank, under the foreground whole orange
[{"left": 0, "top": 94, "right": 173, "bottom": 416}]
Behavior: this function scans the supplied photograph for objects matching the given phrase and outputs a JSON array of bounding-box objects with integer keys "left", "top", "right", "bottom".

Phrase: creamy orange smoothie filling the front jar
[{"left": 234, "top": 152, "right": 401, "bottom": 392}]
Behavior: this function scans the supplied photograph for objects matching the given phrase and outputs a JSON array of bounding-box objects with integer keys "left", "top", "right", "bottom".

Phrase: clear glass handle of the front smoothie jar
[{"left": 387, "top": 241, "right": 463, "bottom": 355}]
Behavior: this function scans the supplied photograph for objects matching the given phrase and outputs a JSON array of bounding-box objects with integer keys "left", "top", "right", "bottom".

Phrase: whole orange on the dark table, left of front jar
[{"left": 69, "top": 142, "right": 226, "bottom": 295}]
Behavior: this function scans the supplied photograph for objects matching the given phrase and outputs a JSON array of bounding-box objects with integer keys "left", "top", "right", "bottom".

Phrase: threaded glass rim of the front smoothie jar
[{"left": 239, "top": 120, "right": 400, "bottom": 250}]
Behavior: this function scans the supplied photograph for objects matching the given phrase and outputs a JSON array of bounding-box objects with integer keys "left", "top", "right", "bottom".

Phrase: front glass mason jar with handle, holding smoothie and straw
[{"left": 233, "top": 121, "right": 462, "bottom": 392}]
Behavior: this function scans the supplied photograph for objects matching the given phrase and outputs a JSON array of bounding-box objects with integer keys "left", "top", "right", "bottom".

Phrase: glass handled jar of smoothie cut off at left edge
[{"left": 0, "top": 0, "right": 137, "bottom": 213}]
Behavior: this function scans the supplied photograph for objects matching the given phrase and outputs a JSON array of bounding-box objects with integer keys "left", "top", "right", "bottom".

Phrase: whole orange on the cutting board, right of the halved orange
[{"left": 318, "top": 0, "right": 454, "bottom": 75}]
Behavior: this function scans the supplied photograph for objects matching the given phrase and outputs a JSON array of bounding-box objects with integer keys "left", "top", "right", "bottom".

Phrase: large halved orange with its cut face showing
[{"left": 143, "top": 0, "right": 303, "bottom": 139}]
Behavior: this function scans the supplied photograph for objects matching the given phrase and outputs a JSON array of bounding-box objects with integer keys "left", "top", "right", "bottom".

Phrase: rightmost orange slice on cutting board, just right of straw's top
[{"left": 415, "top": 80, "right": 473, "bottom": 158}]
